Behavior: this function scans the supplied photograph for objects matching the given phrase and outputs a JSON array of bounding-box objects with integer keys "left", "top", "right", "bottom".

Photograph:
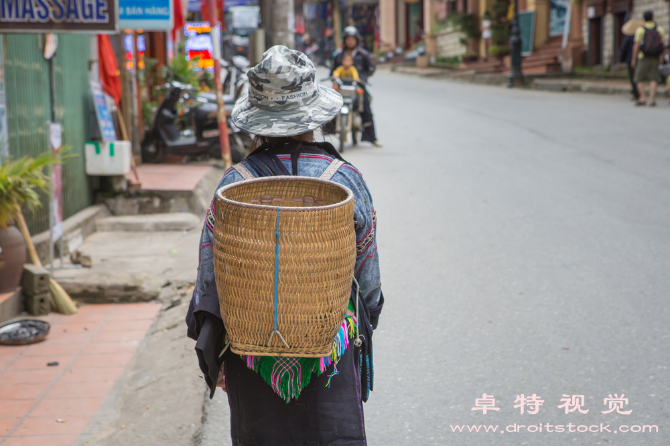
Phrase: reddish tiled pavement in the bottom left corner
[{"left": 0, "top": 303, "right": 160, "bottom": 446}]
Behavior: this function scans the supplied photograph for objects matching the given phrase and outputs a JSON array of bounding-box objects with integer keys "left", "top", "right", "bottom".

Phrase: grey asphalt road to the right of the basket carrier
[{"left": 200, "top": 73, "right": 670, "bottom": 445}]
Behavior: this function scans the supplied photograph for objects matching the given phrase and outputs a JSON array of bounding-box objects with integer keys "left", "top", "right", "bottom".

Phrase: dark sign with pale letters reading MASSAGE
[{"left": 0, "top": 0, "right": 117, "bottom": 33}]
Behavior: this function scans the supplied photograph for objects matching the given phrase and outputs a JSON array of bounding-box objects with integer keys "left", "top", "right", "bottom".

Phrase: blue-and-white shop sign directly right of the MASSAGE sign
[{"left": 119, "top": 0, "right": 174, "bottom": 31}]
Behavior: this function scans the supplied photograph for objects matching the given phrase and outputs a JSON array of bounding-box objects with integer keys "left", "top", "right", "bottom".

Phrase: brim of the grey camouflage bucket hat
[{"left": 231, "top": 85, "right": 343, "bottom": 136}]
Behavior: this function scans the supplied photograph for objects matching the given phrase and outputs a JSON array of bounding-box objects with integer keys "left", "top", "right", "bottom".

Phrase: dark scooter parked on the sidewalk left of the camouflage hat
[{"left": 142, "top": 81, "right": 251, "bottom": 163}]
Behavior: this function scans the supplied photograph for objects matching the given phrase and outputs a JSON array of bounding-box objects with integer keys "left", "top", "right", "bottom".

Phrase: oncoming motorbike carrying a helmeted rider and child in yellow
[{"left": 324, "top": 77, "right": 365, "bottom": 153}]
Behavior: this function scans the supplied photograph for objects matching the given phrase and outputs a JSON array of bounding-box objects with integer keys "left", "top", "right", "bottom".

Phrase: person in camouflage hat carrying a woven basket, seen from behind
[{"left": 186, "top": 46, "right": 384, "bottom": 445}]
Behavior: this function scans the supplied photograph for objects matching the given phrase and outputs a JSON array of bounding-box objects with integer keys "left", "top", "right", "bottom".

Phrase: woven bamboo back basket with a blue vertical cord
[{"left": 214, "top": 176, "right": 356, "bottom": 357}]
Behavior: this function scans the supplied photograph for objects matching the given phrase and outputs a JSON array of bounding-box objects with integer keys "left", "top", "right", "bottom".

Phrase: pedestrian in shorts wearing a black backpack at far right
[{"left": 631, "top": 11, "right": 665, "bottom": 107}]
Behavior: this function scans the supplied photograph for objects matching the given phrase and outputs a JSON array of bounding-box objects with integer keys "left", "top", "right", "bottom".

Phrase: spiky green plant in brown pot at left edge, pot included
[{"left": 0, "top": 146, "right": 60, "bottom": 293}]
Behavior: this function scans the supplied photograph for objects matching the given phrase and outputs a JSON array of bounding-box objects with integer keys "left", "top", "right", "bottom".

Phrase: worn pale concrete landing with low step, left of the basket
[{"left": 54, "top": 213, "right": 202, "bottom": 303}]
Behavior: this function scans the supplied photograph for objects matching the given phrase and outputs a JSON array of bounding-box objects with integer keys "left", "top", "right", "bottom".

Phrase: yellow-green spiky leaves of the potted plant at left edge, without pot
[{"left": 0, "top": 146, "right": 70, "bottom": 229}]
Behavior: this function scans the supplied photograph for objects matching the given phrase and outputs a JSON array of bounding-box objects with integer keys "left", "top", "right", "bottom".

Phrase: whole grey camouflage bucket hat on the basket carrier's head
[{"left": 232, "top": 45, "right": 342, "bottom": 136}]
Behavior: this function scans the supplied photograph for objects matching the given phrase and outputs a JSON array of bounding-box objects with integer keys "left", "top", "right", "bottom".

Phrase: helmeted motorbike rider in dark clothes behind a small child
[{"left": 330, "top": 26, "right": 382, "bottom": 147}]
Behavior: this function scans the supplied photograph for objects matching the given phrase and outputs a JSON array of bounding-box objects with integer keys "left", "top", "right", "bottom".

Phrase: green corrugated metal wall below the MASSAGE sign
[{"left": 2, "top": 34, "right": 92, "bottom": 234}]
